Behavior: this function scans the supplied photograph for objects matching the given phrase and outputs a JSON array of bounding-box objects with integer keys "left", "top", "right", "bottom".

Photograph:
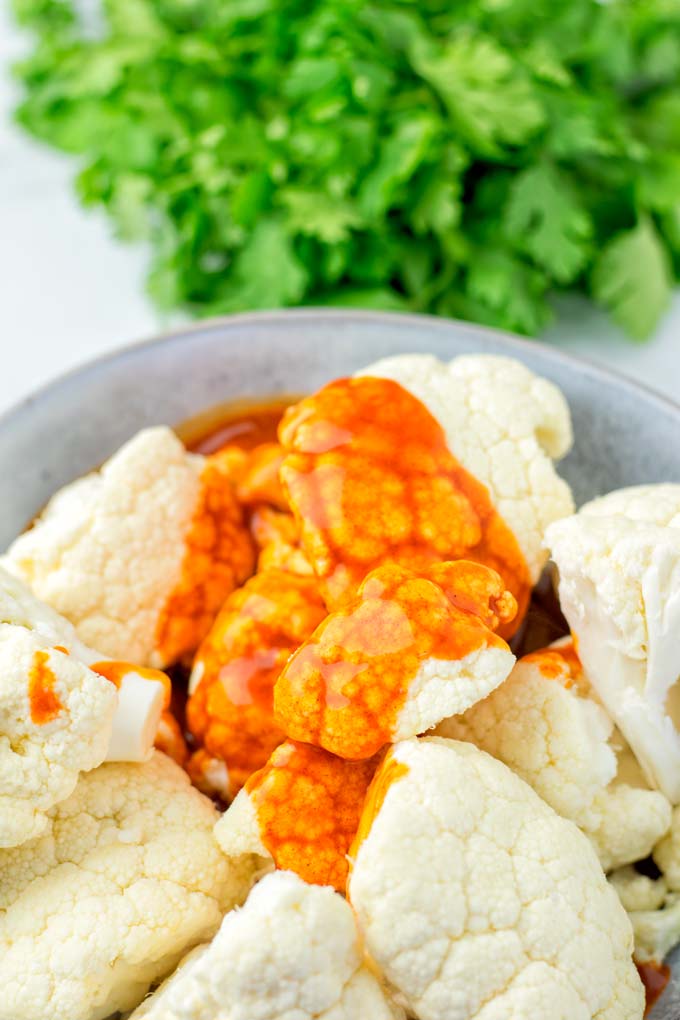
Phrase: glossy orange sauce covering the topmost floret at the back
[{"left": 278, "top": 377, "right": 531, "bottom": 636}]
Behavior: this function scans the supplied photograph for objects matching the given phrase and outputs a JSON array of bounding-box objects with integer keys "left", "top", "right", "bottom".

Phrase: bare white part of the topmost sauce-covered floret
[{"left": 361, "top": 354, "right": 574, "bottom": 583}]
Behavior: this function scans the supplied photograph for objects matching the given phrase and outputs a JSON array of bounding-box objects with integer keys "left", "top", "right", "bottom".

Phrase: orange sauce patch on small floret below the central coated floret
[{"left": 246, "top": 741, "right": 377, "bottom": 893}]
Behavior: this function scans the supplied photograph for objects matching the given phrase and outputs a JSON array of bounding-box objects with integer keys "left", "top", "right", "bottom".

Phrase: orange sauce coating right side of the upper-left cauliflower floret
[{"left": 156, "top": 456, "right": 255, "bottom": 663}]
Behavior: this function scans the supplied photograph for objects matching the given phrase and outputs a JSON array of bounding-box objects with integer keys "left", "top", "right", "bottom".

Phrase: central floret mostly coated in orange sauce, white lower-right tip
[{"left": 274, "top": 560, "right": 516, "bottom": 759}]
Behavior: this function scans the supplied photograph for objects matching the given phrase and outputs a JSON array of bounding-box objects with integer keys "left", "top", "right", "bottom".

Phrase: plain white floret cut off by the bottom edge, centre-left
[{"left": 130, "top": 871, "right": 404, "bottom": 1020}]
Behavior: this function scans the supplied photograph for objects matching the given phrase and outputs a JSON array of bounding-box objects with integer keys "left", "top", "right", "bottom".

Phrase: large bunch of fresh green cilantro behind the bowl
[{"left": 13, "top": 0, "right": 680, "bottom": 339}]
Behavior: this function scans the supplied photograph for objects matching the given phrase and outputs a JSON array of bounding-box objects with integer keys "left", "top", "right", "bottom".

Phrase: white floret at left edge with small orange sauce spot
[{"left": 0, "top": 570, "right": 117, "bottom": 848}]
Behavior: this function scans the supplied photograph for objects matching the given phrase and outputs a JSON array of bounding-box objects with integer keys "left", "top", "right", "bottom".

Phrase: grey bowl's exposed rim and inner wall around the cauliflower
[{"left": 0, "top": 310, "right": 680, "bottom": 1020}]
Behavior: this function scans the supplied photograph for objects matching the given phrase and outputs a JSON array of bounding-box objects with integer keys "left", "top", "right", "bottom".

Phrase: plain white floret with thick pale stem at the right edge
[{"left": 546, "top": 486, "right": 680, "bottom": 804}]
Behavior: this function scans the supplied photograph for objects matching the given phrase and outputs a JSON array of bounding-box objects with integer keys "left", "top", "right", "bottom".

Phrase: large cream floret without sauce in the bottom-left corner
[{"left": 0, "top": 752, "right": 247, "bottom": 1020}]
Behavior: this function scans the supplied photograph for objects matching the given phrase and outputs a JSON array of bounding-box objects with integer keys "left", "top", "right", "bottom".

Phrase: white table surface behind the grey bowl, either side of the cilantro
[{"left": 0, "top": 6, "right": 680, "bottom": 412}]
